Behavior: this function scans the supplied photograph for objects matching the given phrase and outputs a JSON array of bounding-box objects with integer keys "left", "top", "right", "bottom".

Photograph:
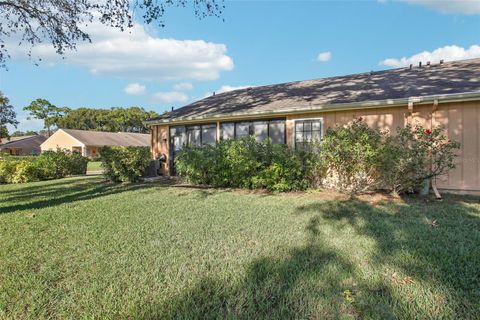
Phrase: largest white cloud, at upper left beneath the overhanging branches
[{"left": 9, "top": 22, "right": 234, "bottom": 80}]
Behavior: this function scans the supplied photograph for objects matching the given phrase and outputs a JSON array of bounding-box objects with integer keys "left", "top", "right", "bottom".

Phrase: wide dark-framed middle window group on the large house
[{"left": 221, "top": 119, "right": 285, "bottom": 143}]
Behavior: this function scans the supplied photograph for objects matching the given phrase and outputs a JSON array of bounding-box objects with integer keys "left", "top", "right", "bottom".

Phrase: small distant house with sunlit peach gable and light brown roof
[{"left": 40, "top": 129, "right": 151, "bottom": 157}]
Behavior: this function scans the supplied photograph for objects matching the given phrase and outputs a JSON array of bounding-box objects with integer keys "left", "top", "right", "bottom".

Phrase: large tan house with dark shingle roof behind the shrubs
[{"left": 147, "top": 59, "right": 480, "bottom": 192}]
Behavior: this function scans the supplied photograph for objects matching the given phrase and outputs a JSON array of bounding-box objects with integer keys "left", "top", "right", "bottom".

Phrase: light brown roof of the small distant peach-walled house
[{"left": 61, "top": 129, "right": 150, "bottom": 147}]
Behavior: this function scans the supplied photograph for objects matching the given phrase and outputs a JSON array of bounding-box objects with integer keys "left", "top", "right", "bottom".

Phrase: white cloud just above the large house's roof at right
[{"left": 380, "top": 45, "right": 480, "bottom": 68}]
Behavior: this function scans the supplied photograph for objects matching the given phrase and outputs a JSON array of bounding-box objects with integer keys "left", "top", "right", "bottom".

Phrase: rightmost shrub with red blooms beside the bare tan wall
[{"left": 380, "top": 125, "right": 460, "bottom": 193}]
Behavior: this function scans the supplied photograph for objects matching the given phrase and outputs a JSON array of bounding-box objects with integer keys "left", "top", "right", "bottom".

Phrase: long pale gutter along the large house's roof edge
[{"left": 144, "top": 91, "right": 480, "bottom": 126}]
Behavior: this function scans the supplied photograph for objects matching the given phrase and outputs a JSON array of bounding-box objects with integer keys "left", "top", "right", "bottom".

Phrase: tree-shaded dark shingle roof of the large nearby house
[{"left": 147, "top": 59, "right": 480, "bottom": 124}]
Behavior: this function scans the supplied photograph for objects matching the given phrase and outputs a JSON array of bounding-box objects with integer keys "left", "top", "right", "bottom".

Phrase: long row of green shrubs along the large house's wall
[{"left": 175, "top": 118, "right": 460, "bottom": 194}]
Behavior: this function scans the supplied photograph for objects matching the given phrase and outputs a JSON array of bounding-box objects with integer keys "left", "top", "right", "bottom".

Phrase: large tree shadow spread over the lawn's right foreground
[{"left": 133, "top": 198, "right": 480, "bottom": 319}]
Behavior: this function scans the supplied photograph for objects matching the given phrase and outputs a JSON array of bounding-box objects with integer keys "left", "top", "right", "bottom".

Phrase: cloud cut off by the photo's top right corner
[{"left": 401, "top": 0, "right": 480, "bottom": 15}]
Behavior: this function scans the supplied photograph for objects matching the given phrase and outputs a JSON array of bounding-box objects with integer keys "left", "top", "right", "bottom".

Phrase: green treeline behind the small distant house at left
[{"left": 24, "top": 99, "right": 158, "bottom": 135}]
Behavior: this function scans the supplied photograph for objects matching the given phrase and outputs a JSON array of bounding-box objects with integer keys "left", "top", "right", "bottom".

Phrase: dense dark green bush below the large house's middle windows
[{"left": 175, "top": 137, "right": 308, "bottom": 191}]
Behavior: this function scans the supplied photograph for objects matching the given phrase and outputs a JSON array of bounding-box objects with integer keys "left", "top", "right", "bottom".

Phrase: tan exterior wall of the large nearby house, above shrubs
[{"left": 152, "top": 101, "right": 480, "bottom": 193}]
